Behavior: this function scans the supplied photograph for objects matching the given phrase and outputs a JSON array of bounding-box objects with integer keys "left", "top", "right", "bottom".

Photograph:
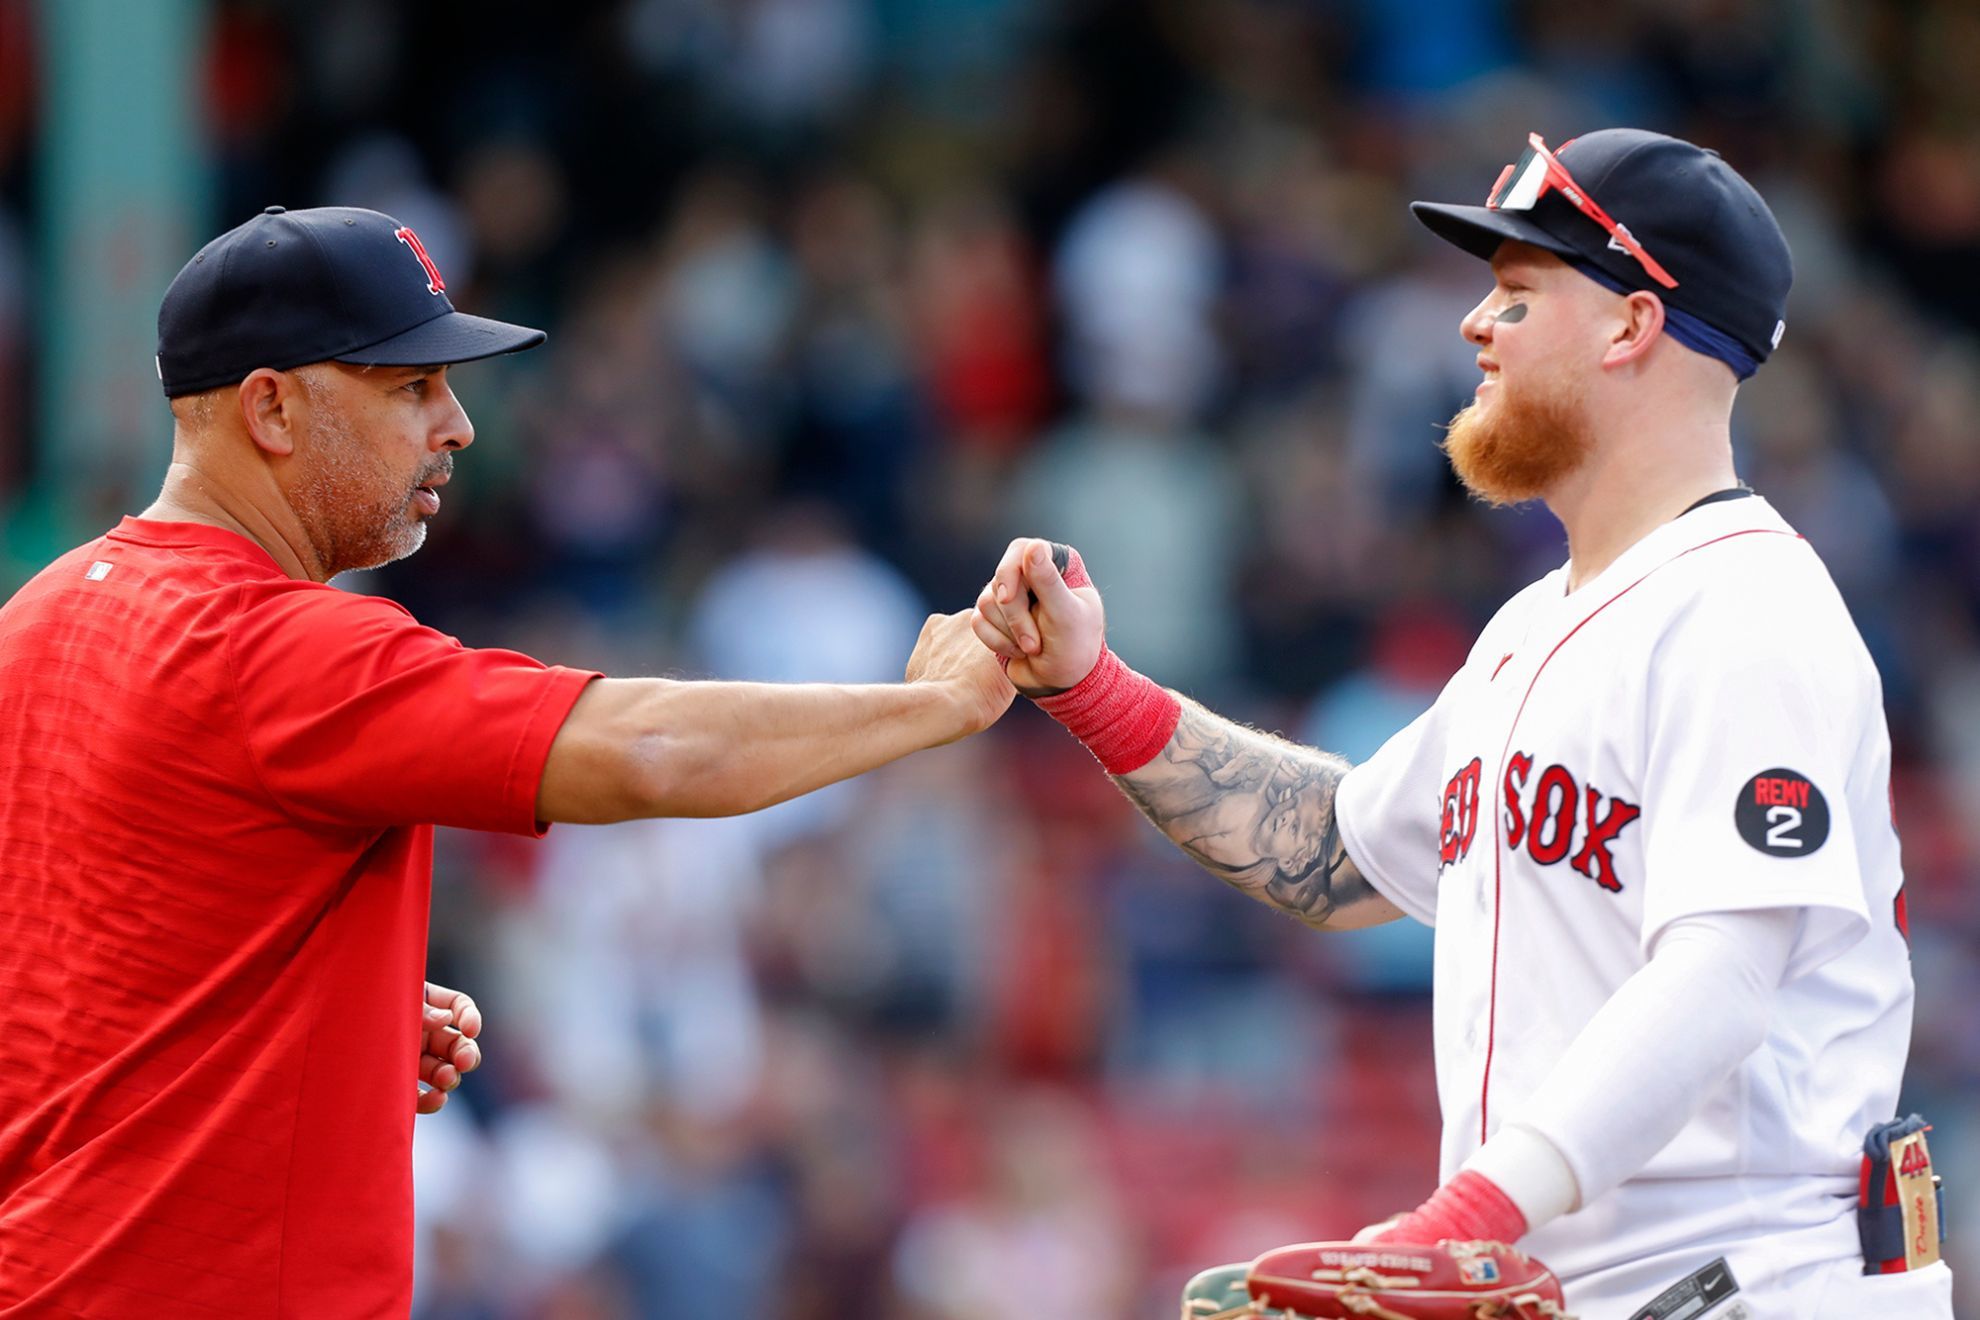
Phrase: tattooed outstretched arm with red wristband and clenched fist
[{"left": 972, "top": 538, "right": 1402, "bottom": 930}]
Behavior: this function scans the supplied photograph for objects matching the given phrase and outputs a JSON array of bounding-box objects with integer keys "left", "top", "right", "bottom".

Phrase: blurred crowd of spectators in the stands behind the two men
[{"left": 0, "top": 0, "right": 1980, "bottom": 1320}]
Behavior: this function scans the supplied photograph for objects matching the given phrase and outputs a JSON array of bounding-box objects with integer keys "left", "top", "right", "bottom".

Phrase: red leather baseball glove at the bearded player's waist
[{"left": 1243, "top": 1241, "right": 1572, "bottom": 1320}]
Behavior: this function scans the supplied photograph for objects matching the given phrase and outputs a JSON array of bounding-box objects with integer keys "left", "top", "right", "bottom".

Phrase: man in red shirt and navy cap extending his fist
[{"left": 0, "top": 208, "right": 1012, "bottom": 1316}]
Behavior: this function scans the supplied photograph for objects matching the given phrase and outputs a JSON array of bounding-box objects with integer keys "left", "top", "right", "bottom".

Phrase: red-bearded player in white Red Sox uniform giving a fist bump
[{"left": 974, "top": 129, "right": 1952, "bottom": 1320}]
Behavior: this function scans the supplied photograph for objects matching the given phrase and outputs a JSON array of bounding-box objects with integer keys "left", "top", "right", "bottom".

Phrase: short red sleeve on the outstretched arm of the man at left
[{"left": 230, "top": 582, "right": 598, "bottom": 833}]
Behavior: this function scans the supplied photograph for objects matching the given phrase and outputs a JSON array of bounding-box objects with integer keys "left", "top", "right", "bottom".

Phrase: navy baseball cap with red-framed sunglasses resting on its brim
[{"left": 1410, "top": 129, "right": 1794, "bottom": 376}]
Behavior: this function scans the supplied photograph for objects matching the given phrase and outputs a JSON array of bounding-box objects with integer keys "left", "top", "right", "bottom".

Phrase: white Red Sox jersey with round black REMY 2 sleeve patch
[{"left": 1337, "top": 497, "right": 1950, "bottom": 1320}]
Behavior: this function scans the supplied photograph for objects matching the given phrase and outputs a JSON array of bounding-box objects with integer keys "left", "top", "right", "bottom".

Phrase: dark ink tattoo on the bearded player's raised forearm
[{"left": 1115, "top": 701, "right": 1378, "bottom": 926}]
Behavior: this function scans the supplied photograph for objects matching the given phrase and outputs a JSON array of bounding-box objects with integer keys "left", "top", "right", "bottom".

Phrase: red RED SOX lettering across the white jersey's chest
[{"left": 1439, "top": 752, "right": 1643, "bottom": 893}]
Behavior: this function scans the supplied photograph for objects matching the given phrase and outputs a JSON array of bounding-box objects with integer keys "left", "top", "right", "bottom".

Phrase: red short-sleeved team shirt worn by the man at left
[{"left": 0, "top": 519, "right": 596, "bottom": 1316}]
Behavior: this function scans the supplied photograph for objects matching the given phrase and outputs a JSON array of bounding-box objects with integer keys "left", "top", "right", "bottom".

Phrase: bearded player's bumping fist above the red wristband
[{"left": 970, "top": 536, "right": 1107, "bottom": 697}]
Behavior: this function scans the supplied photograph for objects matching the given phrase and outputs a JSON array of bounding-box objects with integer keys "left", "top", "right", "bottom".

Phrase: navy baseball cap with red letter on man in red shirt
[{"left": 158, "top": 206, "right": 545, "bottom": 398}]
